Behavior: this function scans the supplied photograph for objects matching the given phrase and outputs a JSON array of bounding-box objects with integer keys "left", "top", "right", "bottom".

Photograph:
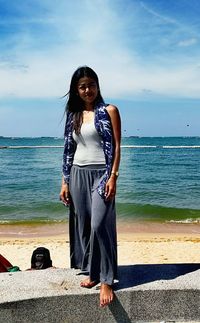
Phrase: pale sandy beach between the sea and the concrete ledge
[{"left": 0, "top": 222, "right": 200, "bottom": 270}]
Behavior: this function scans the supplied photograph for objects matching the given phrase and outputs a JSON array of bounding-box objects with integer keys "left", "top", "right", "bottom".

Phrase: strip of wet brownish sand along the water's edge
[{"left": 0, "top": 221, "right": 200, "bottom": 239}]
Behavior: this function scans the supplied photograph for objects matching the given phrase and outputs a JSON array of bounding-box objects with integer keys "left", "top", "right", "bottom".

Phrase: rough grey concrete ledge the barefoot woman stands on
[{"left": 0, "top": 264, "right": 200, "bottom": 323}]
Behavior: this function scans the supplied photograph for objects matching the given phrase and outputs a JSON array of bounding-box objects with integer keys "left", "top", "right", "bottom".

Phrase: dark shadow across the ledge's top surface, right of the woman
[{"left": 115, "top": 263, "right": 200, "bottom": 290}]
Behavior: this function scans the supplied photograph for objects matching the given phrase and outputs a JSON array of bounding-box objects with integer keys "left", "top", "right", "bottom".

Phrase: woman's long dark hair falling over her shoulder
[{"left": 65, "top": 66, "right": 104, "bottom": 134}]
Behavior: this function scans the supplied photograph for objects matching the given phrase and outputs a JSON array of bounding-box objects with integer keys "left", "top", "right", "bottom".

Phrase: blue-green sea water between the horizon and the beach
[{"left": 0, "top": 137, "right": 200, "bottom": 224}]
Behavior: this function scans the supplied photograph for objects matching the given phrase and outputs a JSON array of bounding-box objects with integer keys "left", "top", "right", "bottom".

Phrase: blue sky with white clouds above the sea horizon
[{"left": 0, "top": 0, "right": 200, "bottom": 137}]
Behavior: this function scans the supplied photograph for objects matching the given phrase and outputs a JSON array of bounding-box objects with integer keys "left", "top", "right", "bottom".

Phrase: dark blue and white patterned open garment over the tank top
[{"left": 63, "top": 103, "right": 114, "bottom": 198}]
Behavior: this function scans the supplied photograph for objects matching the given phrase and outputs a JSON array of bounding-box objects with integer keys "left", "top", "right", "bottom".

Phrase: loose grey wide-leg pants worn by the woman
[{"left": 69, "top": 165, "right": 117, "bottom": 285}]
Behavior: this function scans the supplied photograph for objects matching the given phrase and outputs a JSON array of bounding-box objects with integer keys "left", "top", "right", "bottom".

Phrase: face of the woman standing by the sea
[{"left": 77, "top": 76, "right": 98, "bottom": 105}]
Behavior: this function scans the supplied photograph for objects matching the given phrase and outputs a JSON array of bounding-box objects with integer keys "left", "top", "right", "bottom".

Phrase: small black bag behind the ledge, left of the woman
[{"left": 31, "top": 247, "right": 52, "bottom": 269}]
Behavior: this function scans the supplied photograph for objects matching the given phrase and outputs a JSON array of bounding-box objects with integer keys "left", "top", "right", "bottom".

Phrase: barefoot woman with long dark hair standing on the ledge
[{"left": 60, "top": 66, "right": 121, "bottom": 306}]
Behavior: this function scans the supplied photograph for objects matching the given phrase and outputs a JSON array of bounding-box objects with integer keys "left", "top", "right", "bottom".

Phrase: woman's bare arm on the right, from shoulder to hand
[{"left": 105, "top": 105, "right": 121, "bottom": 200}]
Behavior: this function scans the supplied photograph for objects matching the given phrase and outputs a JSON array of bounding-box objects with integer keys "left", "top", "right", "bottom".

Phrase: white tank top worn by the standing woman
[{"left": 73, "top": 121, "right": 106, "bottom": 166}]
